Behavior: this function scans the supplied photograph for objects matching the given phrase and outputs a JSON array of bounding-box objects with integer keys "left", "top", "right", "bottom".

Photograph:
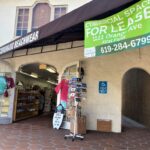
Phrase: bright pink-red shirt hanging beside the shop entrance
[{"left": 55, "top": 79, "right": 69, "bottom": 102}]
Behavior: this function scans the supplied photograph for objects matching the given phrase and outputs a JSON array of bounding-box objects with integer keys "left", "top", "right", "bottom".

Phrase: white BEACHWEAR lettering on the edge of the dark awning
[{"left": 0, "top": 31, "right": 39, "bottom": 55}]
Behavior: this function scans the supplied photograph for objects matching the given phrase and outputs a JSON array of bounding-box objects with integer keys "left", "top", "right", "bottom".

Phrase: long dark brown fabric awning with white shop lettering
[{"left": 0, "top": 0, "right": 139, "bottom": 54}]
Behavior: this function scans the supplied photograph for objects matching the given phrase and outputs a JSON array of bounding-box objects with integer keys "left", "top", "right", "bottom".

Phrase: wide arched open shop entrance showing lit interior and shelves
[{"left": 13, "top": 63, "right": 58, "bottom": 121}]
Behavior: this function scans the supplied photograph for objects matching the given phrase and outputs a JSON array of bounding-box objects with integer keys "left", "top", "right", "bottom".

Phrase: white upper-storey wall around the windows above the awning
[{"left": 0, "top": 0, "right": 90, "bottom": 46}]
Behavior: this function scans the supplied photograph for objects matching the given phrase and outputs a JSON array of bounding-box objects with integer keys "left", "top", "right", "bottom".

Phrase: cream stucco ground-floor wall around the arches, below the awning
[{"left": 2, "top": 41, "right": 150, "bottom": 132}]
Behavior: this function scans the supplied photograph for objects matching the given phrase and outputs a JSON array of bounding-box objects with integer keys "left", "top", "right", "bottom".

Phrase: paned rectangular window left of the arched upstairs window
[{"left": 16, "top": 8, "right": 29, "bottom": 36}]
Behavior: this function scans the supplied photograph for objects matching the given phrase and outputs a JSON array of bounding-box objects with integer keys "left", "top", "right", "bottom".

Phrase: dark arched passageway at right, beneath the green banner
[{"left": 122, "top": 68, "right": 150, "bottom": 128}]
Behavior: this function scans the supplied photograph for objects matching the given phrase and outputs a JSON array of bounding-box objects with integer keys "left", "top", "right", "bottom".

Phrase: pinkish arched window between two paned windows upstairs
[{"left": 32, "top": 3, "right": 51, "bottom": 31}]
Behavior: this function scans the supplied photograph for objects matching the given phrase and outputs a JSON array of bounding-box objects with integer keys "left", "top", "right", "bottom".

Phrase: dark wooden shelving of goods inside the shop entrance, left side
[{"left": 14, "top": 90, "right": 39, "bottom": 121}]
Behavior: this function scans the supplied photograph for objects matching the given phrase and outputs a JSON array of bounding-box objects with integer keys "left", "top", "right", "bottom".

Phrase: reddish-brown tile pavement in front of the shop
[{"left": 0, "top": 116, "right": 150, "bottom": 150}]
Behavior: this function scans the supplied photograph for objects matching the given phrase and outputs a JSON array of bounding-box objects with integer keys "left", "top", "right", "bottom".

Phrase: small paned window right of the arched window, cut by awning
[{"left": 54, "top": 7, "right": 67, "bottom": 19}]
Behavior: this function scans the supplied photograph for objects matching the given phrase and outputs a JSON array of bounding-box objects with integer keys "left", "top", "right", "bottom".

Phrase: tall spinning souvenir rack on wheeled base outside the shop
[{"left": 64, "top": 78, "right": 87, "bottom": 141}]
